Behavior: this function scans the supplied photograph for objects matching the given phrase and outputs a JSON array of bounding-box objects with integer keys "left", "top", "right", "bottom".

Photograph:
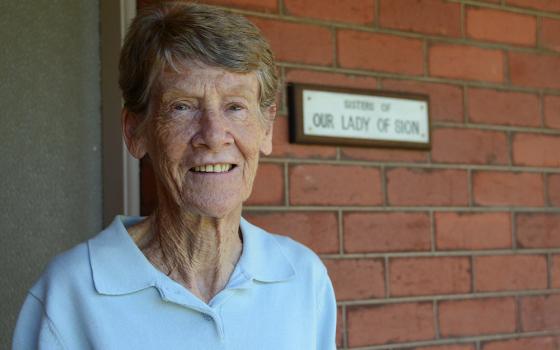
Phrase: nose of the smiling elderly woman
[{"left": 192, "top": 110, "right": 233, "bottom": 151}]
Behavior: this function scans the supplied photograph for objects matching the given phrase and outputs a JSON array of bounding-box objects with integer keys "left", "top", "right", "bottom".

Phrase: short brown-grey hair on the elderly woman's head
[{"left": 119, "top": 2, "right": 278, "bottom": 114}]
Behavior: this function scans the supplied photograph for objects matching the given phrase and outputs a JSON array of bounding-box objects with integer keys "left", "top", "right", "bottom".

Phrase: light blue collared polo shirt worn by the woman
[{"left": 13, "top": 217, "right": 336, "bottom": 350}]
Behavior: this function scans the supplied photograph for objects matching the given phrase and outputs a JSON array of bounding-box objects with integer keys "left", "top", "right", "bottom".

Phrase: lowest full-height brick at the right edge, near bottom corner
[{"left": 520, "top": 294, "right": 560, "bottom": 332}]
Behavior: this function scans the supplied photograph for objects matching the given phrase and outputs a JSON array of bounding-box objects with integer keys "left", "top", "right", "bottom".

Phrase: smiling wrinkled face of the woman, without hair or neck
[{"left": 127, "top": 64, "right": 276, "bottom": 217}]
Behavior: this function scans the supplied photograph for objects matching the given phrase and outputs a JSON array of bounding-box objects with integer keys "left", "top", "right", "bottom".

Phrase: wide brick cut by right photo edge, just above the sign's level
[{"left": 509, "top": 52, "right": 560, "bottom": 89}]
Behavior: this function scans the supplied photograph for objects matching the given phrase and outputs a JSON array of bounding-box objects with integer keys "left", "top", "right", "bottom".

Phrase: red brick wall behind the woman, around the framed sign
[{"left": 139, "top": 0, "right": 560, "bottom": 350}]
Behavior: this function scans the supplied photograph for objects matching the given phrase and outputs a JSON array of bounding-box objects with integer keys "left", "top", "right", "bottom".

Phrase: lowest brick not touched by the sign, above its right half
[{"left": 337, "top": 30, "right": 423, "bottom": 75}]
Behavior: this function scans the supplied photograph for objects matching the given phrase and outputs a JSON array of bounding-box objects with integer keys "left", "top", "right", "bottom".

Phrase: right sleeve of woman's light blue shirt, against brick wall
[{"left": 316, "top": 269, "right": 336, "bottom": 350}]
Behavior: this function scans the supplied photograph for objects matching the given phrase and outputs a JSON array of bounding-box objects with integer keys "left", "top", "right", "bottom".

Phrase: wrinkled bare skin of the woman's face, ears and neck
[{"left": 122, "top": 63, "right": 276, "bottom": 301}]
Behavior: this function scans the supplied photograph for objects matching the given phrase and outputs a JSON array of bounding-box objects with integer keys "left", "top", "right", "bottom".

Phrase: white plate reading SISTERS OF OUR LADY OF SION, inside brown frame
[{"left": 303, "top": 89, "right": 430, "bottom": 144}]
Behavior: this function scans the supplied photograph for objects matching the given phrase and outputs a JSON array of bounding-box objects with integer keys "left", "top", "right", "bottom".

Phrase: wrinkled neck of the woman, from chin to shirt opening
[{"left": 129, "top": 207, "right": 242, "bottom": 303}]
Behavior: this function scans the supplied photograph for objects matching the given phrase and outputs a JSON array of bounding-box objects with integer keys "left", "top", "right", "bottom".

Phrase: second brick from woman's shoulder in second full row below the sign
[{"left": 343, "top": 212, "right": 431, "bottom": 253}]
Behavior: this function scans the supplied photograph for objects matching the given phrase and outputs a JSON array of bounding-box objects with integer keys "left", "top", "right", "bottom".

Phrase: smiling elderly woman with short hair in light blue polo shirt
[{"left": 13, "top": 3, "right": 336, "bottom": 350}]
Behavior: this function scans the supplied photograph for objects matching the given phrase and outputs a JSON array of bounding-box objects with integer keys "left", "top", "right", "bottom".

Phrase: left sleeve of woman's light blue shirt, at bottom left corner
[{"left": 12, "top": 293, "right": 64, "bottom": 350}]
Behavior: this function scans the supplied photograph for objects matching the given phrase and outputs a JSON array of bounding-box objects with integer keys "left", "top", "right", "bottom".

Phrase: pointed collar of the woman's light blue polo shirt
[{"left": 88, "top": 216, "right": 295, "bottom": 295}]
